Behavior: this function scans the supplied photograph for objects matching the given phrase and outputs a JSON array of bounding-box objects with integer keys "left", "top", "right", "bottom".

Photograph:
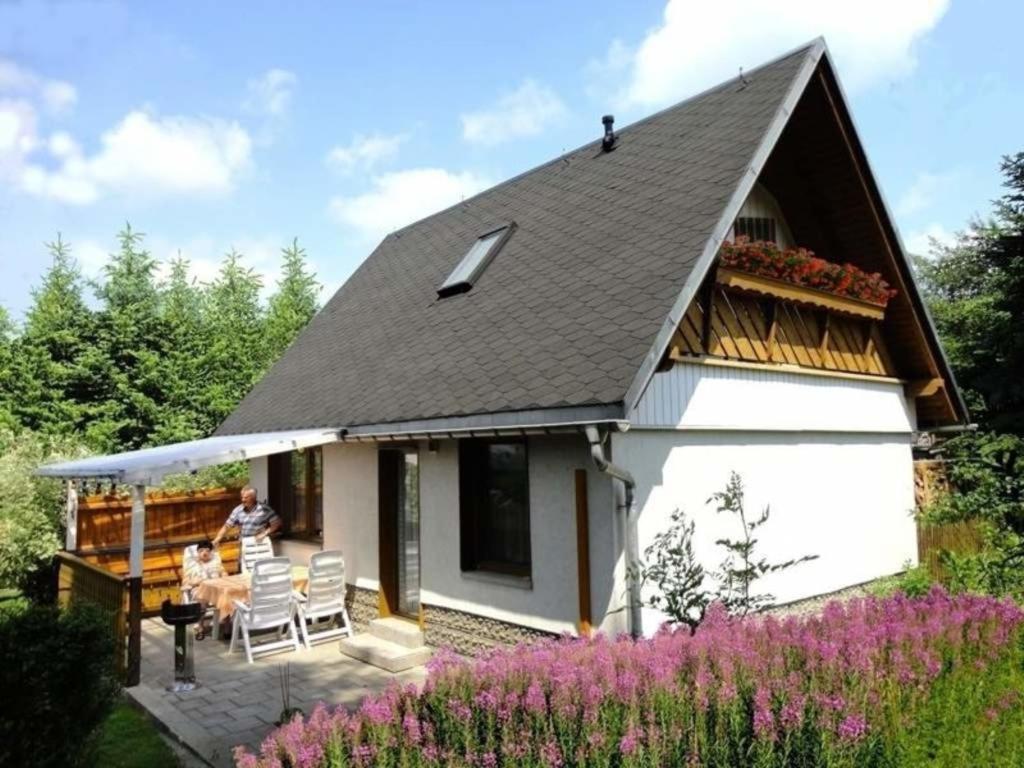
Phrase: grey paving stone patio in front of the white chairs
[{"left": 127, "top": 618, "right": 425, "bottom": 768}]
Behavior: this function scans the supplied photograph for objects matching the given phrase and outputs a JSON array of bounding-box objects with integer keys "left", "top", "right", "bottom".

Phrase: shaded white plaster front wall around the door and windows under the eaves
[{"left": 315, "top": 435, "right": 622, "bottom": 632}]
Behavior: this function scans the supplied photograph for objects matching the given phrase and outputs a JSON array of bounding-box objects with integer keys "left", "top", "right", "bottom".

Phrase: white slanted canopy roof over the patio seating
[{"left": 36, "top": 429, "right": 341, "bottom": 485}]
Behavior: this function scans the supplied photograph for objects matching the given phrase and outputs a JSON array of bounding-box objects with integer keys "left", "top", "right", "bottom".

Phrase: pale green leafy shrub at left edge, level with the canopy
[{"left": 0, "top": 429, "right": 83, "bottom": 596}]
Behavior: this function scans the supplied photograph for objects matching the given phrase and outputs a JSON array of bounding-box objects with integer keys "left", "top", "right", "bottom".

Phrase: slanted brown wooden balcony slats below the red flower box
[{"left": 669, "top": 286, "right": 895, "bottom": 377}]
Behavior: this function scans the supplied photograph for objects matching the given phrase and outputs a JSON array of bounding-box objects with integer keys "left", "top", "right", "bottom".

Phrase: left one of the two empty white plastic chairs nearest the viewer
[{"left": 227, "top": 557, "right": 299, "bottom": 664}]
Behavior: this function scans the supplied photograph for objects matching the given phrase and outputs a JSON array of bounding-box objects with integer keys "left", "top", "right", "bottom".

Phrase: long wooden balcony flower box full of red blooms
[{"left": 718, "top": 239, "right": 896, "bottom": 319}]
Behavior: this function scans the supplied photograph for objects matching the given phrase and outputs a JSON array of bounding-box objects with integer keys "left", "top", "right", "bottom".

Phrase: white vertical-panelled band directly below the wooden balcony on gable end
[{"left": 630, "top": 362, "right": 913, "bottom": 434}]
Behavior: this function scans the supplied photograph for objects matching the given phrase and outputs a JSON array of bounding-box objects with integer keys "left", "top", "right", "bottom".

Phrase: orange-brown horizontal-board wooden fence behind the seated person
[{"left": 74, "top": 488, "right": 239, "bottom": 615}]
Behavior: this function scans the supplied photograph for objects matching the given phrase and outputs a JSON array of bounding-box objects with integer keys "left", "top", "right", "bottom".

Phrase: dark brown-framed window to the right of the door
[{"left": 459, "top": 439, "right": 530, "bottom": 577}]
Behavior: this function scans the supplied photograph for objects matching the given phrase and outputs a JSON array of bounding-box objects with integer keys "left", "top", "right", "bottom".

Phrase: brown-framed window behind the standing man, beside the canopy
[{"left": 267, "top": 447, "right": 324, "bottom": 539}]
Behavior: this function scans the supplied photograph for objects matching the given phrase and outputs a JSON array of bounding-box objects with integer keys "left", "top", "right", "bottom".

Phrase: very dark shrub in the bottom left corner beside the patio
[{"left": 0, "top": 605, "right": 119, "bottom": 768}]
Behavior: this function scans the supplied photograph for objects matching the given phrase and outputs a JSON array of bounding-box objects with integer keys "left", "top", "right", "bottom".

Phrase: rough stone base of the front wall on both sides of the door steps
[{"left": 345, "top": 584, "right": 557, "bottom": 656}]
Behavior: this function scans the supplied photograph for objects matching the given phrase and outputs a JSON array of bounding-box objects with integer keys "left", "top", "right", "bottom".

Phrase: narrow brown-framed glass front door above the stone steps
[{"left": 378, "top": 447, "right": 420, "bottom": 621}]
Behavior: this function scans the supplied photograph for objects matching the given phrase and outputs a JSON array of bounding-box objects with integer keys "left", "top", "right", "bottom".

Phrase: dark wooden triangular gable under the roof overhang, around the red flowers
[{"left": 630, "top": 51, "right": 967, "bottom": 428}]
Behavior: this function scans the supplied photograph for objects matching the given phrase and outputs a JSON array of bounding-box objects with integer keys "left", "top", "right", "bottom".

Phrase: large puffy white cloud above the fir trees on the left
[{"left": 20, "top": 111, "right": 252, "bottom": 205}]
